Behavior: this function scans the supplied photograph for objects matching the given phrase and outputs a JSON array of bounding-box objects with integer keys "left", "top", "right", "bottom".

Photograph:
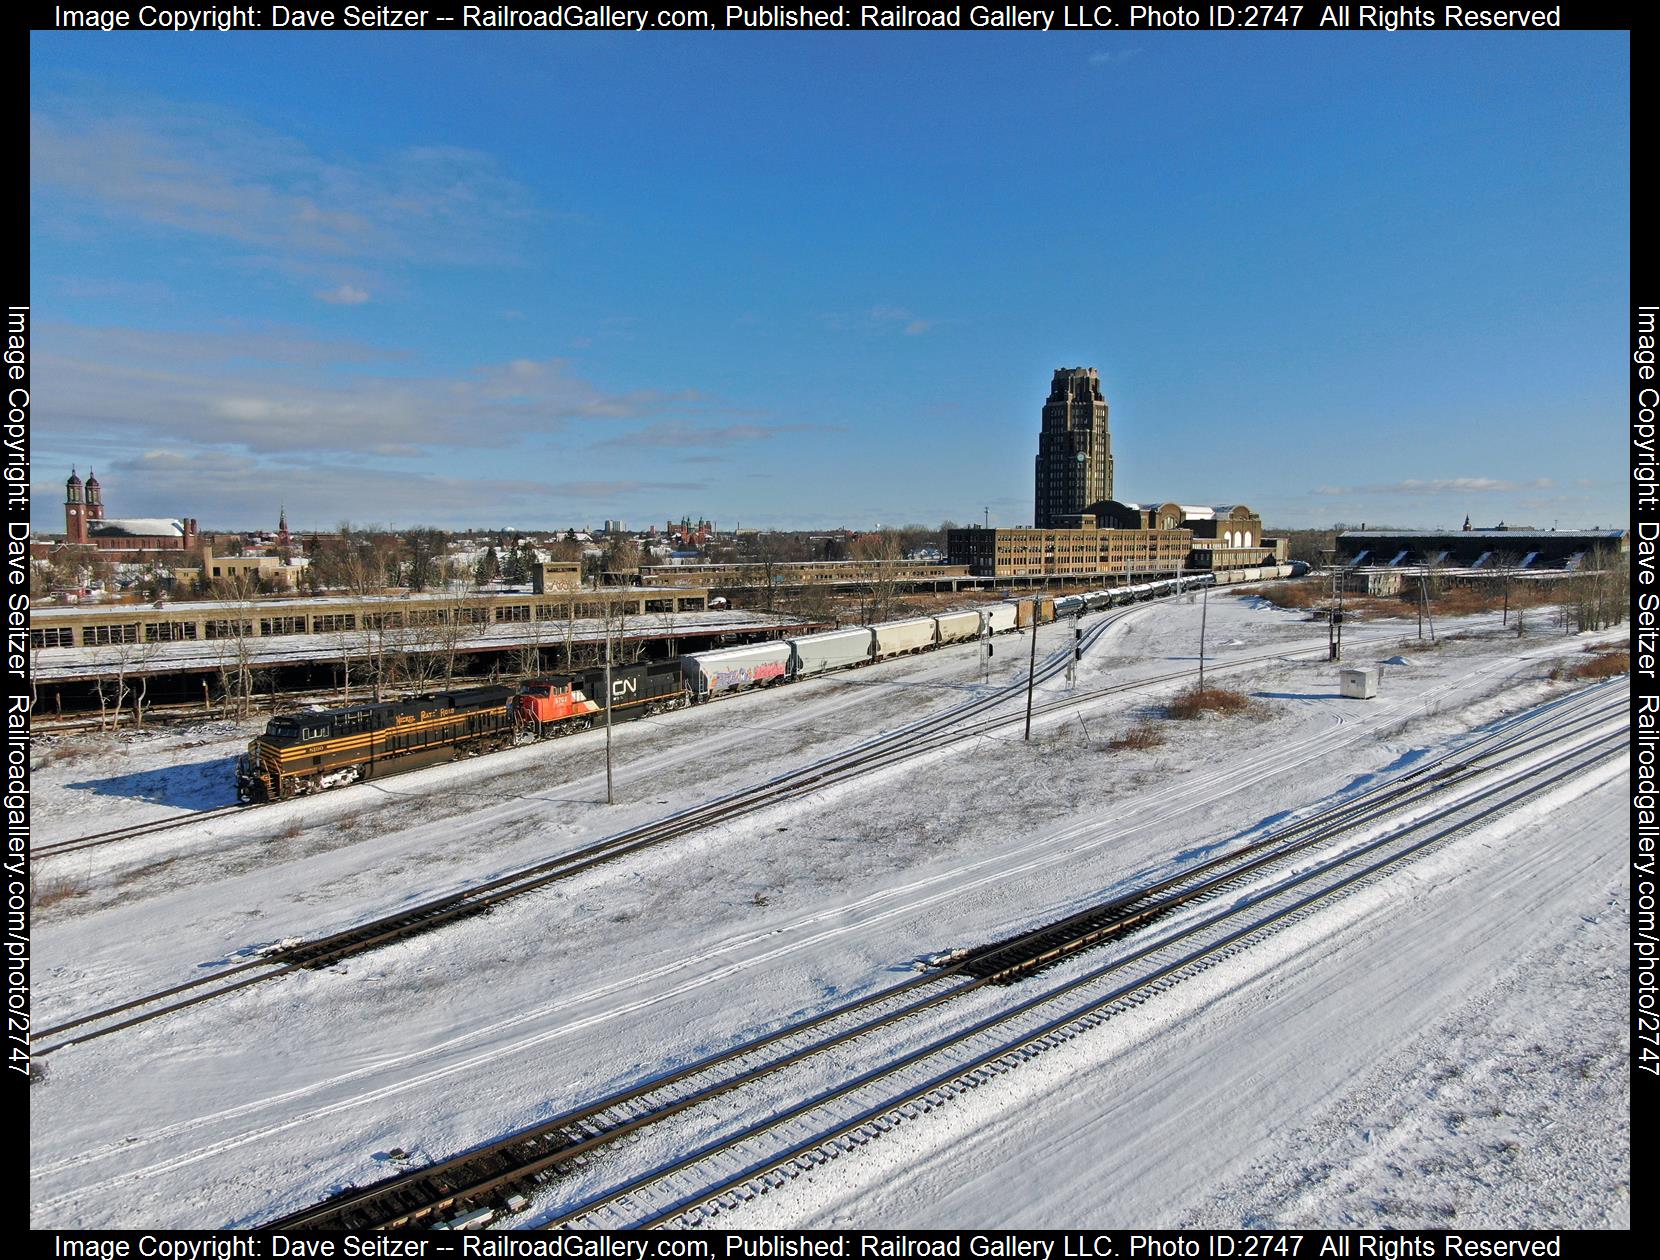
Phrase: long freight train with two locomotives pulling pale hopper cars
[{"left": 236, "top": 569, "right": 1283, "bottom": 802}]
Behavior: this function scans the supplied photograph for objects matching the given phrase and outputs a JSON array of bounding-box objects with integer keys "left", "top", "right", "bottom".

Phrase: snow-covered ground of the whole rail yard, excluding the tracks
[{"left": 32, "top": 596, "right": 1628, "bottom": 1227}]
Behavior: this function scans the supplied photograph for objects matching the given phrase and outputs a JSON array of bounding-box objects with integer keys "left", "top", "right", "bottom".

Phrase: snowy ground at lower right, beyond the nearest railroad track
[{"left": 719, "top": 753, "right": 1630, "bottom": 1228}]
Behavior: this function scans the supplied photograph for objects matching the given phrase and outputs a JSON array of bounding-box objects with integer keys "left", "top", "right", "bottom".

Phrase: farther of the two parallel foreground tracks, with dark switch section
[{"left": 258, "top": 689, "right": 1625, "bottom": 1230}]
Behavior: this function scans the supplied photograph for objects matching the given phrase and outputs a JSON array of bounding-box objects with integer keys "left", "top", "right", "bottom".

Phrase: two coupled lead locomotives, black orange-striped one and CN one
[{"left": 236, "top": 664, "right": 689, "bottom": 802}]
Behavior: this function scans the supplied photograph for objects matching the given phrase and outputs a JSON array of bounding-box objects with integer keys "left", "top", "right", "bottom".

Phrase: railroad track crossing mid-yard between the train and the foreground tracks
[{"left": 33, "top": 609, "right": 1500, "bottom": 1056}]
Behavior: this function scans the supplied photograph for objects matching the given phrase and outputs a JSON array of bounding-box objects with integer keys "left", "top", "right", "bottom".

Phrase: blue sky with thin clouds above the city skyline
[{"left": 30, "top": 32, "right": 1630, "bottom": 530}]
